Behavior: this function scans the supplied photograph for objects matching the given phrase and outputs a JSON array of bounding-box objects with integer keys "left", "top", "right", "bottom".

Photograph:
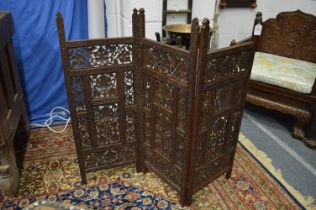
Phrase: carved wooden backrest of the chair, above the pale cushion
[{"left": 258, "top": 10, "right": 316, "bottom": 63}]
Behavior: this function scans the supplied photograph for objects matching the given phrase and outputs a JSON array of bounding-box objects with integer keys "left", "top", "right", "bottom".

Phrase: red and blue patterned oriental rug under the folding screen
[{"left": 0, "top": 125, "right": 302, "bottom": 209}]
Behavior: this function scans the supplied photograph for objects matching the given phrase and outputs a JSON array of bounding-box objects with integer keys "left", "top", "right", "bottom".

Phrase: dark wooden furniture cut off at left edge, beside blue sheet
[{"left": 0, "top": 12, "right": 29, "bottom": 196}]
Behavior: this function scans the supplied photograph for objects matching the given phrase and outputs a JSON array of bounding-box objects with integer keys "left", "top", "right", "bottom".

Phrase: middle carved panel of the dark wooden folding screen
[{"left": 142, "top": 40, "right": 190, "bottom": 191}]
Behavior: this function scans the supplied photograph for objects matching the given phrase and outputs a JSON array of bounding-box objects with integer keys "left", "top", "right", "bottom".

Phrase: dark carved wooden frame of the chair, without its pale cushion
[{"left": 247, "top": 10, "right": 316, "bottom": 148}]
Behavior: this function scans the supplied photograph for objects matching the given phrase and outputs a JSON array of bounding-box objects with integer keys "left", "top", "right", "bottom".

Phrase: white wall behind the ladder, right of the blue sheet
[{"left": 106, "top": 0, "right": 215, "bottom": 39}]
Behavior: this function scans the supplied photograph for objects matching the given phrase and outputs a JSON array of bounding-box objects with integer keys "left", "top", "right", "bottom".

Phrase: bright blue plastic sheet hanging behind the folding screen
[{"left": 0, "top": 0, "right": 88, "bottom": 123}]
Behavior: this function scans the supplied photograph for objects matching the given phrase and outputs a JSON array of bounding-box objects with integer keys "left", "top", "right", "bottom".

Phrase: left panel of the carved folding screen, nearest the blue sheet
[{"left": 57, "top": 13, "right": 137, "bottom": 183}]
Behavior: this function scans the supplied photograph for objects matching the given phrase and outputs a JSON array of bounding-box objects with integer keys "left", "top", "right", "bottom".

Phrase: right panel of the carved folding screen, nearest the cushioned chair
[{"left": 194, "top": 43, "right": 253, "bottom": 189}]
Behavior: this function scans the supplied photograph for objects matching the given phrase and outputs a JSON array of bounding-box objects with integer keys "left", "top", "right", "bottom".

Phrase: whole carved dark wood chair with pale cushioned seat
[{"left": 247, "top": 10, "right": 316, "bottom": 148}]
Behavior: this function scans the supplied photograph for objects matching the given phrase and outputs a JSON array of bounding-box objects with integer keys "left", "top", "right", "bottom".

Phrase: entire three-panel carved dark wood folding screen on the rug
[{"left": 57, "top": 10, "right": 253, "bottom": 205}]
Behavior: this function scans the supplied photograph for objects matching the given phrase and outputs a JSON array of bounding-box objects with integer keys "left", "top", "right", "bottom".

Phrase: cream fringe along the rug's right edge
[{"left": 239, "top": 133, "right": 316, "bottom": 210}]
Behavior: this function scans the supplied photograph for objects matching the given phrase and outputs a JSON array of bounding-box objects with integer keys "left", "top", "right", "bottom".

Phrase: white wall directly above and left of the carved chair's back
[{"left": 218, "top": 0, "right": 316, "bottom": 47}]
